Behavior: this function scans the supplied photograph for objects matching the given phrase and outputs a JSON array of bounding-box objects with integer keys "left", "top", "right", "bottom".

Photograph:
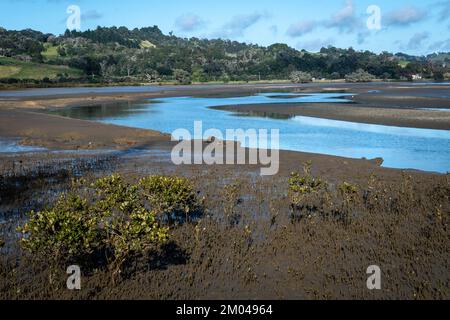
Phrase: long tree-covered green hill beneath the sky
[{"left": 0, "top": 26, "right": 450, "bottom": 83}]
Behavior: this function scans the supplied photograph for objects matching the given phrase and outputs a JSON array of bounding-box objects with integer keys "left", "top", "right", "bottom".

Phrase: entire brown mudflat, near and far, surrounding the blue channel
[{"left": 0, "top": 83, "right": 450, "bottom": 299}]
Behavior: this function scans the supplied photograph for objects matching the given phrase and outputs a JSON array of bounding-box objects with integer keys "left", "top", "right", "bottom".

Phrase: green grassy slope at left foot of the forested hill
[{"left": 0, "top": 57, "right": 83, "bottom": 80}]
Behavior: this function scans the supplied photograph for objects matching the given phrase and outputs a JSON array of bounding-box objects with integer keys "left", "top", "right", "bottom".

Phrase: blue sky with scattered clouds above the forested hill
[{"left": 0, "top": 0, "right": 450, "bottom": 54}]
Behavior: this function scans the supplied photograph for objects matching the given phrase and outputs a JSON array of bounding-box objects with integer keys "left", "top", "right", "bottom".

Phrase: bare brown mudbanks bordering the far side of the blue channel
[{"left": 0, "top": 83, "right": 450, "bottom": 149}]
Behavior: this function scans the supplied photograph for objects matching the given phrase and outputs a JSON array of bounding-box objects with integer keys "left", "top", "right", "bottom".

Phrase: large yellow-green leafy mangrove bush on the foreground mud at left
[{"left": 19, "top": 175, "right": 190, "bottom": 274}]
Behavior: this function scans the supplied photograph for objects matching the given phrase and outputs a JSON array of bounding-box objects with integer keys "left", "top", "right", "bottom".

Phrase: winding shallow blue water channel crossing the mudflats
[{"left": 51, "top": 93, "right": 450, "bottom": 172}]
